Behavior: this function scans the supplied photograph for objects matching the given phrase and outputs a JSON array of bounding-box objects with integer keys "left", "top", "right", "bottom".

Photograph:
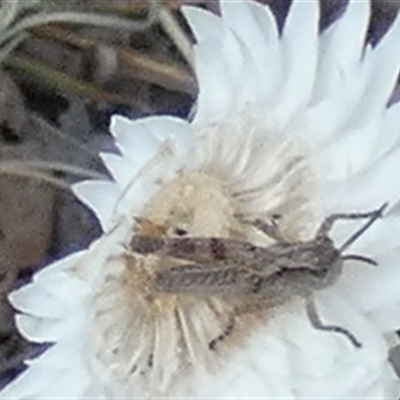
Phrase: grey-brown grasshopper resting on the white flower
[{"left": 130, "top": 203, "right": 387, "bottom": 348}]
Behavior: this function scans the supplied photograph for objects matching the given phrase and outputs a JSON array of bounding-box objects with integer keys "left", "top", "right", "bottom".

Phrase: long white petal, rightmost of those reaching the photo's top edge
[{"left": 288, "top": 0, "right": 372, "bottom": 145}]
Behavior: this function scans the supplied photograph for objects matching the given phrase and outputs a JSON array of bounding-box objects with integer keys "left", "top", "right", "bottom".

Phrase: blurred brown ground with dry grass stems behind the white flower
[{"left": 0, "top": 0, "right": 400, "bottom": 388}]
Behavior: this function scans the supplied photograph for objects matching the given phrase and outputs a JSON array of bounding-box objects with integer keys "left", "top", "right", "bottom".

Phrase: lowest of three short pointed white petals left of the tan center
[{"left": 72, "top": 181, "right": 120, "bottom": 232}]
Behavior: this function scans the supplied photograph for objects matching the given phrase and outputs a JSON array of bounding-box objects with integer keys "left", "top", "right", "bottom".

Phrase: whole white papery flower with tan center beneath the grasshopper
[{"left": 1, "top": 0, "right": 400, "bottom": 399}]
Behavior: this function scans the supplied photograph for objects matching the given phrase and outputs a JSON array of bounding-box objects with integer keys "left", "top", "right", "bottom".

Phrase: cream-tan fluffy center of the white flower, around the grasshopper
[{"left": 91, "top": 119, "right": 317, "bottom": 395}]
